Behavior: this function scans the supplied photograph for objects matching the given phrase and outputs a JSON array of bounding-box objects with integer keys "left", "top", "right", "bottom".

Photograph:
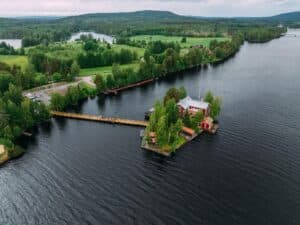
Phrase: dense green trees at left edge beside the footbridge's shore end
[{"left": 0, "top": 64, "right": 50, "bottom": 157}]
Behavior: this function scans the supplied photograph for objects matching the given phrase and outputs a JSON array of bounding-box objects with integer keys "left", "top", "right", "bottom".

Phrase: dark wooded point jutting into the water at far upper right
[{"left": 244, "top": 27, "right": 287, "bottom": 43}]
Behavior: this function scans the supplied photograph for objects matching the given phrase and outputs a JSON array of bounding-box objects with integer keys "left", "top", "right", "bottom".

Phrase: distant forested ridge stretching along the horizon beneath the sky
[{"left": 0, "top": 11, "right": 292, "bottom": 47}]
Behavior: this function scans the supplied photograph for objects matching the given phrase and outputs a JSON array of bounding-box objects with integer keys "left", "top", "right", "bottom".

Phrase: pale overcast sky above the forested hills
[{"left": 0, "top": 0, "right": 300, "bottom": 16}]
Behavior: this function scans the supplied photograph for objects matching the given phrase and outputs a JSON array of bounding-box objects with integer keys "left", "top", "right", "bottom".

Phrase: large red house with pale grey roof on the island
[{"left": 177, "top": 96, "right": 209, "bottom": 116}]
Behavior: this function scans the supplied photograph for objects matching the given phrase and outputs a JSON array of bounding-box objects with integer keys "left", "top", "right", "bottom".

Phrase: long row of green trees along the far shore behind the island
[{"left": 95, "top": 35, "right": 243, "bottom": 93}]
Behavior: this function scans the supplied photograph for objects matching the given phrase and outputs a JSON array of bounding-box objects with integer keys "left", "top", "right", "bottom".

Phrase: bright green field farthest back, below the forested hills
[{"left": 131, "top": 35, "right": 231, "bottom": 48}]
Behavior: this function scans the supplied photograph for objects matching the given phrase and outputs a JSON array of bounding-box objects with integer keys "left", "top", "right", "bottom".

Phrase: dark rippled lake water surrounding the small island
[{"left": 0, "top": 31, "right": 300, "bottom": 225}]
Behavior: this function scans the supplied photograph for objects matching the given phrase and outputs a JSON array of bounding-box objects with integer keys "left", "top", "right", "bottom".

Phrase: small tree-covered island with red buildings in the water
[{"left": 141, "top": 87, "right": 221, "bottom": 156}]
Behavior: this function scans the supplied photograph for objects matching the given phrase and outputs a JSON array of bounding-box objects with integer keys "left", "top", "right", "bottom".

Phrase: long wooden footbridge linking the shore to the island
[{"left": 51, "top": 111, "right": 148, "bottom": 127}]
